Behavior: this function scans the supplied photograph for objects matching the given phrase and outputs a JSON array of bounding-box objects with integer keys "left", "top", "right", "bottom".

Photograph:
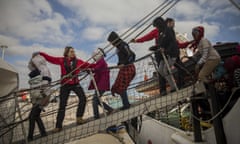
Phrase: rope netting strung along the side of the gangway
[{"left": 1, "top": 55, "right": 204, "bottom": 143}]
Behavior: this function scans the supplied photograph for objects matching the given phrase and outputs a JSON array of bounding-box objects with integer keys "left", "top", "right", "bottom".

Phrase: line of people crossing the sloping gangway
[{"left": 28, "top": 17, "right": 239, "bottom": 140}]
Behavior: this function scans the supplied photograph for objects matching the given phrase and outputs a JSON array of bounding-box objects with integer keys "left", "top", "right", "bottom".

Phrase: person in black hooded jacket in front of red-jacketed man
[{"left": 150, "top": 17, "right": 180, "bottom": 95}]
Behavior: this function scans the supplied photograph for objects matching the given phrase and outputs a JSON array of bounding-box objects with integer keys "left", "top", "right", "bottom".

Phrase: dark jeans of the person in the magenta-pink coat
[{"left": 92, "top": 90, "right": 113, "bottom": 118}]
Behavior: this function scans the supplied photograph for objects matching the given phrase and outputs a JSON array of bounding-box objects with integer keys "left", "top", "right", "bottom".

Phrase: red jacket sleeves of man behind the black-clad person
[{"left": 136, "top": 28, "right": 189, "bottom": 48}]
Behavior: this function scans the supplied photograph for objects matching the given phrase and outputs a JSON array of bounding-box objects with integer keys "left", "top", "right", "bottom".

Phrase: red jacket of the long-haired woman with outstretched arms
[{"left": 40, "top": 52, "right": 94, "bottom": 84}]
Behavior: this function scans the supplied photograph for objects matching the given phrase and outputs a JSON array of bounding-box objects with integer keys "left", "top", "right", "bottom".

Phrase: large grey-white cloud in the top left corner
[{"left": 0, "top": 0, "right": 73, "bottom": 44}]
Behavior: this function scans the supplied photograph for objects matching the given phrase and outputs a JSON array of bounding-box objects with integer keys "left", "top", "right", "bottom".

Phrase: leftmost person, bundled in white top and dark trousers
[{"left": 28, "top": 54, "right": 51, "bottom": 141}]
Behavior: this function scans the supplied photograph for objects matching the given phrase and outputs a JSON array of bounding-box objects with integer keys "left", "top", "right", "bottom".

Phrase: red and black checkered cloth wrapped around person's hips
[{"left": 111, "top": 64, "right": 136, "bottom": 94}]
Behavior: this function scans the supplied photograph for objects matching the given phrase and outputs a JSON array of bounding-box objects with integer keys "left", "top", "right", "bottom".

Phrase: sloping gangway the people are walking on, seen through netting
[{"left": 12, "top": 83, "right": 205, "bottom": 144}]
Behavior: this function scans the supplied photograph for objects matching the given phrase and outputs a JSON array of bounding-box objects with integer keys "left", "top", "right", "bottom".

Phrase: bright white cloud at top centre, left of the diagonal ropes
[{"left": 59, "top": 0, "right": 161, "bottom": 28}]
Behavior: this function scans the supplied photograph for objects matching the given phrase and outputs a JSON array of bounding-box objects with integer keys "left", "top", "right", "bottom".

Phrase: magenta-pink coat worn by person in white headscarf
[{"left": 88, "top": 58, "right": 110, "bottom": 91}]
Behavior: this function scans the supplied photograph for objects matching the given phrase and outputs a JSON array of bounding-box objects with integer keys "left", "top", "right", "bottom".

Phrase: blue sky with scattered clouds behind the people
[{"left": 0, "top": 0, "right": 240, "bottom": 88}]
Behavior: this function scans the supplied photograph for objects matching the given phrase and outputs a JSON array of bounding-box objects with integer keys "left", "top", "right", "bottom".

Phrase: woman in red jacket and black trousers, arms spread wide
[{"left": 40, "top": 46, "right": 91, "bottom": 132}]
